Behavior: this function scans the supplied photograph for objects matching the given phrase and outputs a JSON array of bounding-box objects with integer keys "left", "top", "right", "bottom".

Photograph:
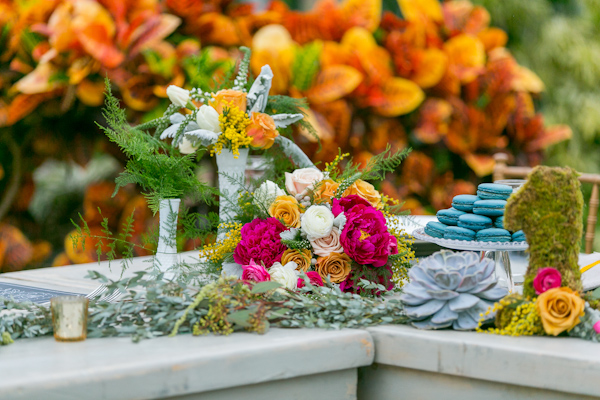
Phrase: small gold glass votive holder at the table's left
[{"left": 50, "top": 296, "right": 89, "bottom": 342}]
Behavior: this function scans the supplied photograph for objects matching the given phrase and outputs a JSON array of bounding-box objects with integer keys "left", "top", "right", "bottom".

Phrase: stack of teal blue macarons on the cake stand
[{"left": 425, "top": 183, "right": 525, "bottom": 242}]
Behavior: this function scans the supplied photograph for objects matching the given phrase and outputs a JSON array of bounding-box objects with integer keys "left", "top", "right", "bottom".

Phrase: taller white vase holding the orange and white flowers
[{"left": 217, "top": 148, "right": 249, "bottom": 239}]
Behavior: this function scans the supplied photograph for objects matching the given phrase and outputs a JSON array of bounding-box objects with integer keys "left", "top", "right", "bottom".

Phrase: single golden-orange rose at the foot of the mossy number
[{"left": 536, "top": 287, "right": 585, "bottom": 336}]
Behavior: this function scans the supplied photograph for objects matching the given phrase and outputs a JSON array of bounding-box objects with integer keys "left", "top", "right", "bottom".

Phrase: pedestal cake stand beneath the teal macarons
[{"left": 412, "top": 228, "right": 529, "bottom": 293}]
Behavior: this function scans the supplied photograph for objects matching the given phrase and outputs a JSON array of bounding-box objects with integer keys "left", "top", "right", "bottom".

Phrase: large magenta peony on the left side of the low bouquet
[{"left": 233, "top": 218, "right": 287, "bottom": 269}]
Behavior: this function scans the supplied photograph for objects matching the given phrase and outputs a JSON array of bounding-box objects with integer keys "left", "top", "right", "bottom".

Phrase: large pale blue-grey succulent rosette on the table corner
[{"left": 400, "top": 250, "right": 508, "bottom": 330}]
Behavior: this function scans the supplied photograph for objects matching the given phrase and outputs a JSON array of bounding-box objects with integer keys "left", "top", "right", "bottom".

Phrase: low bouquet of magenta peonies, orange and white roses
[{"left": 200, "top": 148, "right": 414, "bottom": 294}]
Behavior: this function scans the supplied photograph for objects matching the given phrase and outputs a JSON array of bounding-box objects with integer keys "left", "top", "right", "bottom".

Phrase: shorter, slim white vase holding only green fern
[{"left": 155, "top": 199, "right": 181, "bottom": 280}]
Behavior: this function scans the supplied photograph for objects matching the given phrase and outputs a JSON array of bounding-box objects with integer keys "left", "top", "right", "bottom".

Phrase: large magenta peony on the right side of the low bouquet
[{"left": 340, "top": 205, "right": 398, "bottom": 267}]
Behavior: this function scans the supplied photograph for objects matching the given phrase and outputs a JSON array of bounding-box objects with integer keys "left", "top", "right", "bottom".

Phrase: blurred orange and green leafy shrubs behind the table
[{"left": 0, "top": 0, "right": 600, "bottom": 272}]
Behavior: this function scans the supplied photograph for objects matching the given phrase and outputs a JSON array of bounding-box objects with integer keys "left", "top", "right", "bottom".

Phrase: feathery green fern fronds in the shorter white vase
[{"left": 98, "top": 80, "right": 216, "bottom": 213}]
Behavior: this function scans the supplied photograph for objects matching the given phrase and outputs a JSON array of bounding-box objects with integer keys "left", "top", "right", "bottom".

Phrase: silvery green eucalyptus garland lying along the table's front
[{"left": 0, "top": 271, "right": 406, "bottom": 344}]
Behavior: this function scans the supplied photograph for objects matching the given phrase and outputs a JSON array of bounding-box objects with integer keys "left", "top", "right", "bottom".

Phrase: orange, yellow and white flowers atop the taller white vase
[{"left": 155, "top": 47, "right": 304, "bottom": 158}]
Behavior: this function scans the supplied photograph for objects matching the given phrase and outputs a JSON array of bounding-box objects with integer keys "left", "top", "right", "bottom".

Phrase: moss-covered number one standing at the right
[{"left": 504, "top": 166, "right": 583, "bottom": 297}]
